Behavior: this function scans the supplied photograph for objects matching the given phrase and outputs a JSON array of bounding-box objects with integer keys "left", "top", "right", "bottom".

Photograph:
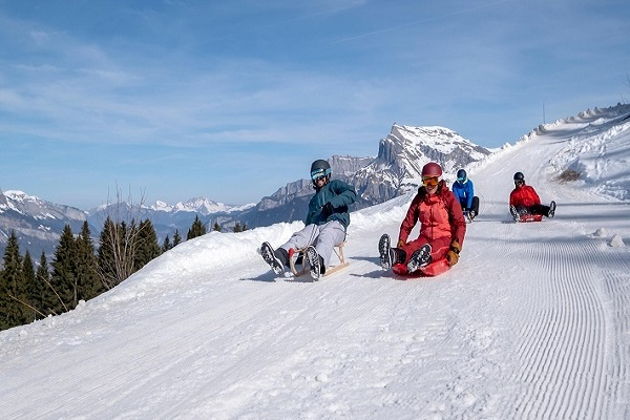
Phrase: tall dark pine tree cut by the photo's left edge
[{"left": 0, "top": 231, "right": 27, "bottom": 330}]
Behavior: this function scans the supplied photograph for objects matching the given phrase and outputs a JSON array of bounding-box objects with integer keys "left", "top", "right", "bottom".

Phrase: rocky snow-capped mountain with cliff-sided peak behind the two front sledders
[{"left": 234, "top": 124, "right": 491, "bottom": 226}]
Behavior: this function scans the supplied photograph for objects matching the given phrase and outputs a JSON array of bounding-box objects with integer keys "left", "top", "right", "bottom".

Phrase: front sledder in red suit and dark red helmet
[{"left": 379, "top": 162, "right": 466, "bottom": 274}]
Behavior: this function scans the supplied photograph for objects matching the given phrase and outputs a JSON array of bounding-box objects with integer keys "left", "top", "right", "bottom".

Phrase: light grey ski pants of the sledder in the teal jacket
[{"left": 280, "top": 220, "right": 346, "bottom": 267}]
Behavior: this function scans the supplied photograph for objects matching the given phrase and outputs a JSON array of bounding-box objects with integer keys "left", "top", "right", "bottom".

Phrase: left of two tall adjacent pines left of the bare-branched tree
[{"left": 50, "top": 225, "right": 78, "bottom": 313}]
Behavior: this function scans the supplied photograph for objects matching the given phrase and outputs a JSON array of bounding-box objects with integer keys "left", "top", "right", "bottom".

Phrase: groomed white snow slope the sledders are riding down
[{"left": 0, "top": 106, "right": 630, "bottom": 419}]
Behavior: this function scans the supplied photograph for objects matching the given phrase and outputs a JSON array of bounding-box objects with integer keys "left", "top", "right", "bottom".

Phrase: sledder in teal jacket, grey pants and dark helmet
[{"left": 260, "top": 159, "right": 357, "bottom": 279}]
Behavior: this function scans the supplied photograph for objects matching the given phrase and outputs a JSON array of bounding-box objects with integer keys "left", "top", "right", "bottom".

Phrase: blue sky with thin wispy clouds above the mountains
[{"left": 0, "top": 0, "right": 630, "bottom": 208}]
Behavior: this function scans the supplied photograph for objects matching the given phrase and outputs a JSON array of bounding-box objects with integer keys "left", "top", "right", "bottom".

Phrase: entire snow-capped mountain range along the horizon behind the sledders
[{"left": 0, "top": 124, "right": 492, "bottom": 255}]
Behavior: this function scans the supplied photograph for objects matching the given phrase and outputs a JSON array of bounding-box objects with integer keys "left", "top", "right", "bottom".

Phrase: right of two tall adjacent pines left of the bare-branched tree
[{"left": 73, "top": 221, "right": 104, "bottom": 306}]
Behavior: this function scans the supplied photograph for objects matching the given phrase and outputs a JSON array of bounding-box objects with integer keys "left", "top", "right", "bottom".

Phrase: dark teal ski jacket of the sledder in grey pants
[{"left": 304, "top": 179, "right": 357, "bottom": 228}]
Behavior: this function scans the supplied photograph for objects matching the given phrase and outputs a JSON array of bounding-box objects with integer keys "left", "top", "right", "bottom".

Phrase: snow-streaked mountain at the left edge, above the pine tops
[{"left": 0, "top": 190, "right": 86, "bottom": 258}]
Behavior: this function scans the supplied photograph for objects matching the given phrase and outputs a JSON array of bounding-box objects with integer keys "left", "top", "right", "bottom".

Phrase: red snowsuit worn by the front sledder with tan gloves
[{"left": 398, "top": 181, "right": 466, "bottom": 265}]
